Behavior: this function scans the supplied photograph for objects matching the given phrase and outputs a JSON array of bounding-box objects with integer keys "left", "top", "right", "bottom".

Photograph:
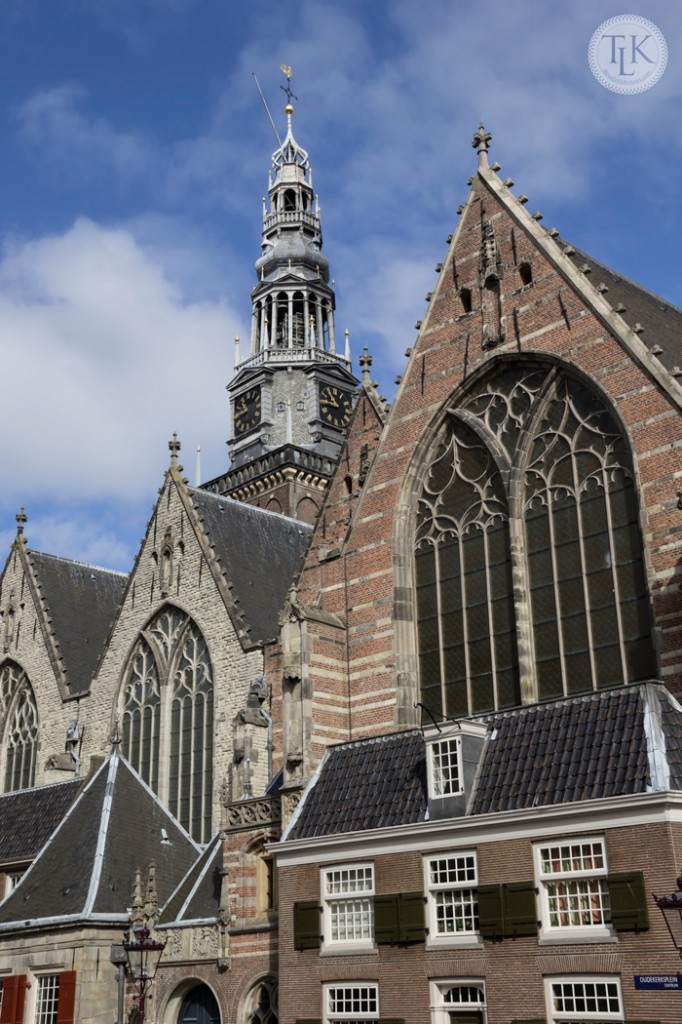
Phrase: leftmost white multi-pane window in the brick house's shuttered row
[{"left": 322, "top": 864, "right": 374, "bottom": 945}]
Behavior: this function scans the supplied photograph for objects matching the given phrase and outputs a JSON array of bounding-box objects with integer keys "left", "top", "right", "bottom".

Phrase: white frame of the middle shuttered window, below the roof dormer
[{"left": 424, "top": 850, "right": 483, "bottom": 946}]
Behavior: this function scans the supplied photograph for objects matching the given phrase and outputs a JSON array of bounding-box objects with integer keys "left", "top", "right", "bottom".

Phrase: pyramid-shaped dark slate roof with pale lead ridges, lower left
[{"left": 0, "top": 753, "right": 200, "bottom": 932}]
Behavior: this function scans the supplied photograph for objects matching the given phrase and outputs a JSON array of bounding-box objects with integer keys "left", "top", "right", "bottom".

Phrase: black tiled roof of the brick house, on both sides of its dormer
[{"left": 283, "top": 683, "right": 682, "bottom": 842}]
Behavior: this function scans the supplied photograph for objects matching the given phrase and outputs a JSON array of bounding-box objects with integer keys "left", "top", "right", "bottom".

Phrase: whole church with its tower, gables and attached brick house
[{"left": 0, "top": 75, "right": 682, "bottom": 1024}]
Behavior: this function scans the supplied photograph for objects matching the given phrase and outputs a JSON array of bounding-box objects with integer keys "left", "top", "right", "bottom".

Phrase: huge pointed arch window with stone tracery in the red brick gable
[{"left": 415, "top": 362, "right": 656, "bottom": 716}]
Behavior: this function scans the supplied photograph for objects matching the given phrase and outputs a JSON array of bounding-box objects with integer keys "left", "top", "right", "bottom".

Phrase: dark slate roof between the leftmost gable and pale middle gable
[{"left": 27, "top": 550, "right": 128, "bottom": 694}]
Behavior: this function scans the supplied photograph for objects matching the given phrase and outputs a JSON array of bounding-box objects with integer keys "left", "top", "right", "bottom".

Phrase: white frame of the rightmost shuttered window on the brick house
[{"left": 534, "top": 836, "right": 617, "bottom": 943}]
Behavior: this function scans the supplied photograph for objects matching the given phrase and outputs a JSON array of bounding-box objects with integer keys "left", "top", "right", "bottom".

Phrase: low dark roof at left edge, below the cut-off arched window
[{"left": 0, "top": 778, "right": 84, "bottom": 864}]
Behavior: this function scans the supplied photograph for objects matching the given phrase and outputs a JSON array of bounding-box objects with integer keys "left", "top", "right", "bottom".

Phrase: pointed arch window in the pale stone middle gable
[{"left": 120, "top": 606, "right": 213, "bottom": 842}]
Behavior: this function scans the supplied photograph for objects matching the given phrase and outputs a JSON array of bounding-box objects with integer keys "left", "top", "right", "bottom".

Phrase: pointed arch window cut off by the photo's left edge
[{"left": 0, "top": 662, "right": 38, "bottom": 793}]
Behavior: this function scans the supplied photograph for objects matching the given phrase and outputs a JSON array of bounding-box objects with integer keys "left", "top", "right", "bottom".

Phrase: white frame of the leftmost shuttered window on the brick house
[{"left": 319, "top": 861, "right": 376, "bottom": 952}]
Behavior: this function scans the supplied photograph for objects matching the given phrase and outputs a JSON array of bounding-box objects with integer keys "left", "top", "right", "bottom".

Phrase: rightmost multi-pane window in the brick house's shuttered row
[{"left": 536, "top": 839, "right": 610, "bottom": 933}]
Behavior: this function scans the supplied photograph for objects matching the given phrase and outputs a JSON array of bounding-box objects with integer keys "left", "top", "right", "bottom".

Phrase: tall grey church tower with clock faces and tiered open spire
[{"left": 205, "top": 83, "right": 357, "bottom": 522}]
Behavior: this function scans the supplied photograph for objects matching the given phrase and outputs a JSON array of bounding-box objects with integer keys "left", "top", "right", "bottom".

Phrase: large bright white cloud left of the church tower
[{"left": 0, "top": 219, "right": 244, "bottom": 514}]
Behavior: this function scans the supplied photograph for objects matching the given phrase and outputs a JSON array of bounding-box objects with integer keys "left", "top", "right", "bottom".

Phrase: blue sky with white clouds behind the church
[{"left": 0, "top": 0, "right": 682, "bottom": 569}]
